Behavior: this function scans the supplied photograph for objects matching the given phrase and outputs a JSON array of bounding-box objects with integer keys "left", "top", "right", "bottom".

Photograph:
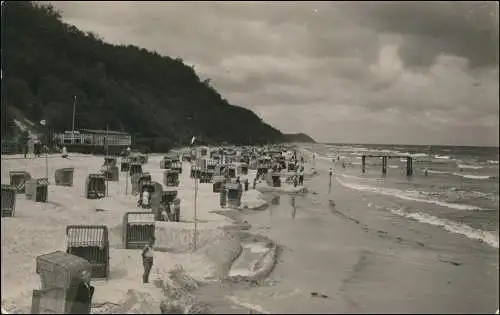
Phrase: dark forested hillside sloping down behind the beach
[{"left": 2, "top": 1, "right": 284, "bottom": 151}]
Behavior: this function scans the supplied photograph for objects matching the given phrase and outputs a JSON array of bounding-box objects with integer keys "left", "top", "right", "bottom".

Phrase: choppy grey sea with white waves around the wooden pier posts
[{"left": 306, "top": 144, "right": 499, "bottom": 248}]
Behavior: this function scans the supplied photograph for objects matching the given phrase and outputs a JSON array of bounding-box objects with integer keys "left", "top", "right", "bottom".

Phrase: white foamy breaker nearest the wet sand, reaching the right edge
[{"left": 389, "top": 209, "right": 498, "bottom": 248}]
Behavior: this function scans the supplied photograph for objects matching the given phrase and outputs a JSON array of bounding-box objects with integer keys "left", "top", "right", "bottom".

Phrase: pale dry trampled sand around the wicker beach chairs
[{"left": 1, "top": 155, "right": 265, "bottom": 314}]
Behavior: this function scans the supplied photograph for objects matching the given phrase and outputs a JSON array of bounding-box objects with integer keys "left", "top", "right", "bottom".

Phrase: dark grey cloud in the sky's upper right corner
[{"left": 349, "top": 1, "right": 499, "bottom": 67}]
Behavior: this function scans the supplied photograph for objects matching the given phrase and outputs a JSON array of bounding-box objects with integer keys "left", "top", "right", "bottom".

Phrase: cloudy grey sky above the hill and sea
[{"left": 45, "top": 1, "right": 499, "bottom": 146}]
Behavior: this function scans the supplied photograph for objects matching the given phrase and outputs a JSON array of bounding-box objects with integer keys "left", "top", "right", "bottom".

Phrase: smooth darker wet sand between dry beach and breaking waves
[{"left": 229, "top": 159, "right": 498, "bottom": 313}]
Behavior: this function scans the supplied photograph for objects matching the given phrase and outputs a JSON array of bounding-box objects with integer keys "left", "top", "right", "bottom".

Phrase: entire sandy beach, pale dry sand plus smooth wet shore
[{"left": 2, "top": 151, "right": 498, "bottom": 314}]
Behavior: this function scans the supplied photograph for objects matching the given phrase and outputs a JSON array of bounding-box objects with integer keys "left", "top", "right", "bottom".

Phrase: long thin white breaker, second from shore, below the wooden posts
[{"left": 336, "top": 178, "right": 487, "bottom": 211}]
